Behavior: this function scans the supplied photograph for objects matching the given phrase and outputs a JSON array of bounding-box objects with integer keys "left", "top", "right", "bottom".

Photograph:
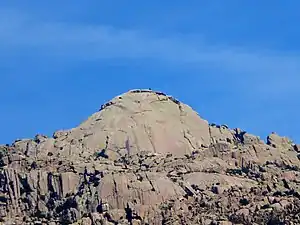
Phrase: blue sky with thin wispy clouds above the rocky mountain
[{"left": 0, "top": 0, "right": 300, "bottom": 144}]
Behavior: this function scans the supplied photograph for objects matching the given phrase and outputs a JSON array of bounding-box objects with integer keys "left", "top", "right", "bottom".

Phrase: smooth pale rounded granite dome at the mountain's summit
[{"left": 68, "top": 90, "right": 210, "bottom": 158}]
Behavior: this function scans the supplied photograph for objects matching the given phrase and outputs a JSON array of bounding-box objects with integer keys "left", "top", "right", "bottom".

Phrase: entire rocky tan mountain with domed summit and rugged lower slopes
[{"left": 0, "top": 90, "right": 300, "bottom": 225}]
